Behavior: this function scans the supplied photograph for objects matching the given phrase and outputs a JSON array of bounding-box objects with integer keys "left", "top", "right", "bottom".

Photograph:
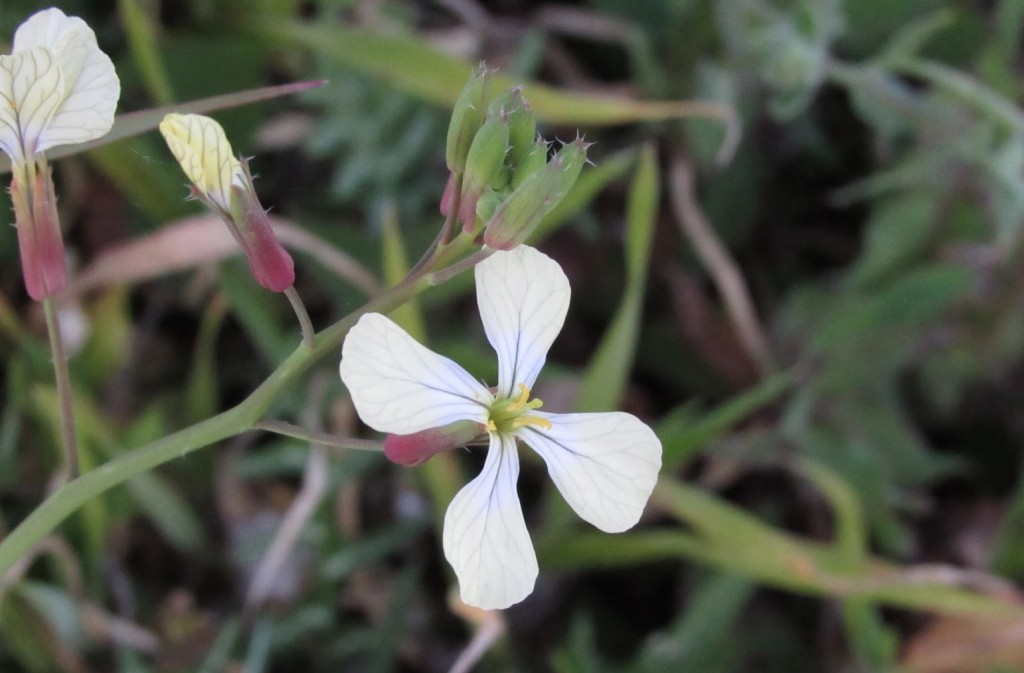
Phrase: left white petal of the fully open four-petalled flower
[{"left": 341, "top": 313, "right": 490, "bottom": 434}]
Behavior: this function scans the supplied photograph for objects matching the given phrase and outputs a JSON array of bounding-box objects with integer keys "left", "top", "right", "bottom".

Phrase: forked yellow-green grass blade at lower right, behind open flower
[{"left": 538, "top": 476, "right": 1024, "bottom": 619}]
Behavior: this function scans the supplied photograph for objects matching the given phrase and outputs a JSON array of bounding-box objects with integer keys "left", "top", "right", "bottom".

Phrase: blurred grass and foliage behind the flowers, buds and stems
[{"left": 0, "top": 0, "right": 1024, "bottom": 673}]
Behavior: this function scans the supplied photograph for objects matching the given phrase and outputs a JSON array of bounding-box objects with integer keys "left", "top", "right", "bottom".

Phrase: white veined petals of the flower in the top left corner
[{"left": 0, "top": 8, "right": 121, "bottom": 164}]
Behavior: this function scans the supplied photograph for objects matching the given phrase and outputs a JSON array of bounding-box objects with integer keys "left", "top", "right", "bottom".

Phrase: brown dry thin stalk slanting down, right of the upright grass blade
[{"left": 669, "top": 154, "right": 774, "bottom": 374}]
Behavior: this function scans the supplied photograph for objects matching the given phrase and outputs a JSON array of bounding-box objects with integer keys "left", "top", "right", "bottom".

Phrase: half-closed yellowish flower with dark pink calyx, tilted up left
[{"left": 160, "top": 114, "right": 295, "bottom": 292}]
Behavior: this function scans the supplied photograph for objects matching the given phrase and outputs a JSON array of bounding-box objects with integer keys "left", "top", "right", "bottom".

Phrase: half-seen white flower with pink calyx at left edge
[{"left": 0, "top": 8, "right": 121, "bottom": 300}]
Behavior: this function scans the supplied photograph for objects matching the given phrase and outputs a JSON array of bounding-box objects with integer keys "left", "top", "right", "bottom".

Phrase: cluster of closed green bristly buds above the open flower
[{"left": 440, "top": 66, "right": 590, "bottom": 250}]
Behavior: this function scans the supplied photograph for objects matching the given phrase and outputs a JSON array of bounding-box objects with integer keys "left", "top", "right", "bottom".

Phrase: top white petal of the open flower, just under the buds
[{"left": 476, "top": 246, "right": 569, "bottom": 396}]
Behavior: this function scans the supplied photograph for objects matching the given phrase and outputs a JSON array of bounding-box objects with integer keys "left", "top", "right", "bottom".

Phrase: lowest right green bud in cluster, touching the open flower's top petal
[{"left": 483, "top": 138, "right": 590, "bottom": 250}]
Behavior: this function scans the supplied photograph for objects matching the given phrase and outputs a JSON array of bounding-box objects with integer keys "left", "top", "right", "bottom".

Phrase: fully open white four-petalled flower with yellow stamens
[{"left": 341, "top": 246, "right": 662, "bottom": 609}]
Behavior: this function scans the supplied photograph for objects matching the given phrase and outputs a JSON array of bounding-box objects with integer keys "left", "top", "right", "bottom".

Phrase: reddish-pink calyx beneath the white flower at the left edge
[{"left": 10, "top": 165, "right": 68, "bottom": 301}]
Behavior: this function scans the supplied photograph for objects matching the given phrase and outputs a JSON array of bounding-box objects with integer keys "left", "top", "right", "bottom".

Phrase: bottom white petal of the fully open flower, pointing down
[{"left": 443, "top": 434, "right": 537, "bottom": 609}]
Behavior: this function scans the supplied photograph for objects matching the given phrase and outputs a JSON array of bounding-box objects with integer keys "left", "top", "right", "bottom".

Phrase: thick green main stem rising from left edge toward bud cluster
[{"left": 0, "top": 260, "right": 456, "bottom": 576}]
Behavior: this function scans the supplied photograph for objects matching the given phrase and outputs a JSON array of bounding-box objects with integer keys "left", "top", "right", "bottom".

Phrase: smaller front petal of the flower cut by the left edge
[{"left": 0, "top": 47, "right": 65, "bottom": 163}]
